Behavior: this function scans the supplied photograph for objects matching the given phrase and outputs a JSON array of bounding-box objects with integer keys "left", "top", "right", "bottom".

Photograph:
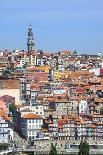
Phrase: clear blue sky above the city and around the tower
[{"left": 0, "top": 0, "right": 103, "bottom": 54}]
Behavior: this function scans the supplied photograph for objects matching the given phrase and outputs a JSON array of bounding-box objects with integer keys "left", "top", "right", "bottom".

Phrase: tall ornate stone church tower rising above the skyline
[{"left": 27, "top": 25, "right": 35, "bottom": 52}]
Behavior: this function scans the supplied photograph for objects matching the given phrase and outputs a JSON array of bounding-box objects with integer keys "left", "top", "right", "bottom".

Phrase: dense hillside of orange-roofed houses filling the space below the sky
[{"left": 0, "top": 24, "right": 103, "bottom": 145}]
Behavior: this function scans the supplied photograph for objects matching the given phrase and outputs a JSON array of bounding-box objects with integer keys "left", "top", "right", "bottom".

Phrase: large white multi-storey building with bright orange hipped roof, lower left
[{"left": 20, "top": 113, "right": 43, "bottom": 141}]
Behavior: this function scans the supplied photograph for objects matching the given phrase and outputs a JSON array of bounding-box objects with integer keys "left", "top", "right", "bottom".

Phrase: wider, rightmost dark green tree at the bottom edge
[{"left": 78, "top": 140, "right": 89, "bottom": 155}]
